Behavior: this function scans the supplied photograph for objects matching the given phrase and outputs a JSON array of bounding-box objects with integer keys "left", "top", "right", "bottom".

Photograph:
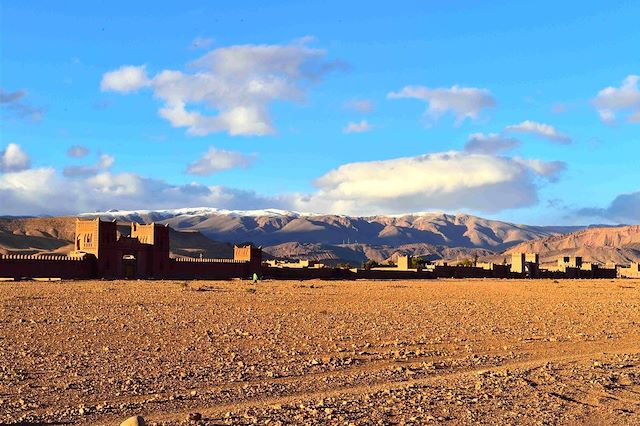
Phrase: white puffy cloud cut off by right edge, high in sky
[{"left": 593, "top": 75, "right": 640, "bottom": 123}]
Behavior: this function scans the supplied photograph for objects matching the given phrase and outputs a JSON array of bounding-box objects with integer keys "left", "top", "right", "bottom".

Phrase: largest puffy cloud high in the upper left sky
[{"left": 101, "top": 39, "right": 342, "bottom": 136}]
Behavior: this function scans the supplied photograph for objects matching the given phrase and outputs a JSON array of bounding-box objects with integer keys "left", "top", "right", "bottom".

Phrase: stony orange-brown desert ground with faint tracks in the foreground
[{"left": 0, "top": 280, "right": 640, "bottom": 425}]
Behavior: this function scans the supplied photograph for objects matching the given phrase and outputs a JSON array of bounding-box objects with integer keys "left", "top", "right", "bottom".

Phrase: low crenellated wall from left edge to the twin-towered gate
[{"left": 0, "top": 254, "right": 96, "bottom": 280}]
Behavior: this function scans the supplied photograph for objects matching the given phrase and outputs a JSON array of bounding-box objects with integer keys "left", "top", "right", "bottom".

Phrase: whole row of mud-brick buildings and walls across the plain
[{"left": 0, "top": 218, "right": 640, "bottom": 280}]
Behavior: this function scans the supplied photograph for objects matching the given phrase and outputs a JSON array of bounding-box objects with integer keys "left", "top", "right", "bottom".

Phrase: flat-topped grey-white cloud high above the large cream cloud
[{"left": 387, "top": 86, "right": 496, "bottom": 124}]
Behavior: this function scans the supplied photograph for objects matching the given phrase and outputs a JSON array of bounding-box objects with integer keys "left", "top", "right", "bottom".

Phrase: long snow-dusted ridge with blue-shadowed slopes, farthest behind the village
[{"left": 79, "top": 208, "right": 582, "bottom": 252}]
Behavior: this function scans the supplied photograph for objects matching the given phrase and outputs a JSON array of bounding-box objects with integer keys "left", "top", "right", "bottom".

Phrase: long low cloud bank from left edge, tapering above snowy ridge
[{"left": 0, "top": 168, "right": 291, "bottom": 215}]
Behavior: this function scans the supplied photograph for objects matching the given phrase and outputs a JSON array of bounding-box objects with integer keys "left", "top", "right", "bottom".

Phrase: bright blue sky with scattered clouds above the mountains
[{"left": 0, "top": 0, "right": 640, "bottom": 225}]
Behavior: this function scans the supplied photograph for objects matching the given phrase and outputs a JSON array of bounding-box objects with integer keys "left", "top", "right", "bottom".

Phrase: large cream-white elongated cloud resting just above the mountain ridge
[{"left": 297, "top": 151, "right": 559, "bottom": 214}]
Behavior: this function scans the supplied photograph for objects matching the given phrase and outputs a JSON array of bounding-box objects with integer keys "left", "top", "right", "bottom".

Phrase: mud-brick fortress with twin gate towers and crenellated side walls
[{"left": 0, "top": 218, "right": 262, "bottom": 279}]
